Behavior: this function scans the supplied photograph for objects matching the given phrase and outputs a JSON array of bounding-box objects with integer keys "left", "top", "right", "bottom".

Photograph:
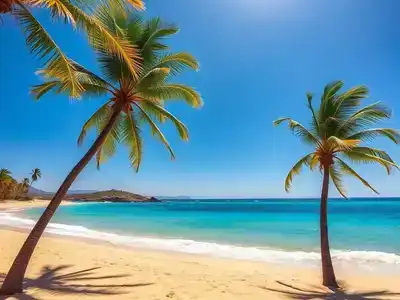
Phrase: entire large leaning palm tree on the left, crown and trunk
[{"left": 0, "top": 7, "right": 202, "bottom": 294}]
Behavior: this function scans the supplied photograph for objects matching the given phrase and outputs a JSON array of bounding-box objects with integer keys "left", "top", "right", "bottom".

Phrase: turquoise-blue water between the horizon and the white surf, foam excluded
[{"left": 22, "top": 199, "right": 400, "bottom": 254}]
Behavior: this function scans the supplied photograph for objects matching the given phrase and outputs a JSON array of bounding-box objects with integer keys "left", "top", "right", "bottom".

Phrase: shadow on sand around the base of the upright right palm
[{"left": 260, "top": 281, "right": 400, "bottom": 300}]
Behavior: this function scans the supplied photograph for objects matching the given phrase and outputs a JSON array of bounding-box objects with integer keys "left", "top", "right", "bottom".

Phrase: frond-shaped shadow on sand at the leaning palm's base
[{"left": 0, "top": 265, "right": 154, "bottom": 300}]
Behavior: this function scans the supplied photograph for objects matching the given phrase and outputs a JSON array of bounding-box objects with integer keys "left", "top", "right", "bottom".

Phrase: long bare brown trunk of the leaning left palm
[{"left": 0, "top": 107, "right": 121, "bottom": 295}]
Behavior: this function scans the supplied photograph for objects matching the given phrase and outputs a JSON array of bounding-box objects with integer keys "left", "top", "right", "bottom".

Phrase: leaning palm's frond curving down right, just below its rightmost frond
[{"left": 140, "top": 100, "right": 189, "bottom": 141}]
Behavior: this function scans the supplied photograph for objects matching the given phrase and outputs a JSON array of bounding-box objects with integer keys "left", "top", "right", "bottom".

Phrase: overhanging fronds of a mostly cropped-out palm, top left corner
[{"left": 0, "top": 0, "right": 144, "bottom": 98}]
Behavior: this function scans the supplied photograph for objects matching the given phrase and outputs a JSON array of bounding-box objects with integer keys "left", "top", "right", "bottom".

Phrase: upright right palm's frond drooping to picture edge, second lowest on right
[{"left": 341, "top": 147, "right": 399, "bottom": 174}]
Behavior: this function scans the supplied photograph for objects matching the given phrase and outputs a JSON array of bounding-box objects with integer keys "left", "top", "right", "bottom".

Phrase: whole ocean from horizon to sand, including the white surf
[{"left": 0, "top": 198, "right": 400, "bottom": 273}]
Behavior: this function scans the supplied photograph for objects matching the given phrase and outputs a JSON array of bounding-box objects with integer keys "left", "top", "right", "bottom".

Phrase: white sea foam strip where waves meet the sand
[{"left": 0, "top": 212, "right": 400, "bottom": 272}]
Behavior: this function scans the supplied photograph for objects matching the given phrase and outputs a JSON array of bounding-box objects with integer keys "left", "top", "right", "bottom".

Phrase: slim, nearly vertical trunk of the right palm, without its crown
[{"left": 319, "top": 166, "right": 339, "bottom": 288}]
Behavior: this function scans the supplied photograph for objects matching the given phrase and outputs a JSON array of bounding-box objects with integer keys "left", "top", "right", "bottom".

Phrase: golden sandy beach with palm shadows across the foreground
[{"left": 0, "top": 201, "right": 400, "bottom": 300}]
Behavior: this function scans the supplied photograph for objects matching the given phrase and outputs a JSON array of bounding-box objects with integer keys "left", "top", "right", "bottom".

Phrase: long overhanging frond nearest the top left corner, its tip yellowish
[{"left": 13, "top": 2, "right": 83, "bottom": 98}]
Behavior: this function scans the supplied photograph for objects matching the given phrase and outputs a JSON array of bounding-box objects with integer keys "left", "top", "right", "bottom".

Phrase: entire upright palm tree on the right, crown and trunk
[{"left": 274, "top": 81, "right": 400, "bottom": 287}]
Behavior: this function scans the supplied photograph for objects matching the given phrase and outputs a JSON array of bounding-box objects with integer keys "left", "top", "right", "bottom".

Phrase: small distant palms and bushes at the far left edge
[{"left": 0, "top": 168, "right": 41, "bottom": 201}]
